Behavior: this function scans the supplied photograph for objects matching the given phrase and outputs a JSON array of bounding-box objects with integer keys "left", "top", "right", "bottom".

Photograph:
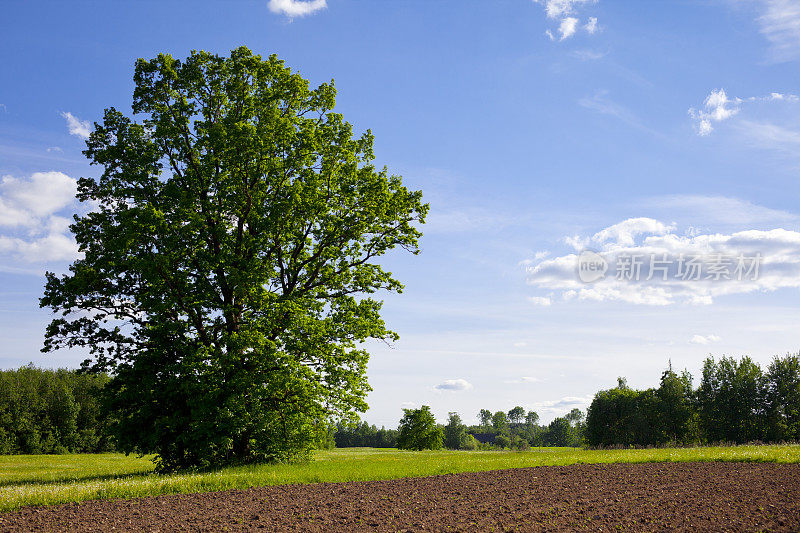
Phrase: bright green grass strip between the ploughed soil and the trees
[{"left": 0, "top": 445, "right": 800, "bottom": 511}]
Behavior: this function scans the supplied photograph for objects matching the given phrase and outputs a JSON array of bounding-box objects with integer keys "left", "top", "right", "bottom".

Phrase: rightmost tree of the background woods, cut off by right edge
[{"left": 766, "top": 354, "right": 800, "bottom": 441}]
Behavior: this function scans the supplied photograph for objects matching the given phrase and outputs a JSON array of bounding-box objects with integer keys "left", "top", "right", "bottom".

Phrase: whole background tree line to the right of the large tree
[{"left": 346, "top": 354, "right": 800, "bottom": 450}]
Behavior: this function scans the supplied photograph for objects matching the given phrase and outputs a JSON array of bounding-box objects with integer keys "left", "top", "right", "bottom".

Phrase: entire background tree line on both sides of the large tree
[{"left": 0, "top": 354, "right": 800, "bottom": 454}]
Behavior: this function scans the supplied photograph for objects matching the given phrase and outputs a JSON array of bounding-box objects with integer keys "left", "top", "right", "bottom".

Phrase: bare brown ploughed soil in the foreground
[{"left": 0, "top": 463, "right": 800, "bottom": 531}]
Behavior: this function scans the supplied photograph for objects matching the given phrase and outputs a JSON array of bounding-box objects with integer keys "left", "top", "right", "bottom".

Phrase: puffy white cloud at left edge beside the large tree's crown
[{"left": 0, "top": 172, "right": 78, "bottom": 263}]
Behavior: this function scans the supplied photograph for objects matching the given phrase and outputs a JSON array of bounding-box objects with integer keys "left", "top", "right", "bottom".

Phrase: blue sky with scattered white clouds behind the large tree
[{"left": 0, "top": 0, "right": 800, "bottom": 426}]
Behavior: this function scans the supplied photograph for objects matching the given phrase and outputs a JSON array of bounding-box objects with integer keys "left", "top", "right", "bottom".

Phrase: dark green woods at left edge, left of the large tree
[{"left": 0, "top": 365, "right": 113, "bottom": 454}]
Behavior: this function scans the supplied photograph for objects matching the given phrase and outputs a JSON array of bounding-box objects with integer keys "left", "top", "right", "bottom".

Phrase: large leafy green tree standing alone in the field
[{"left": 39, "top": 47, "right": 428, "bottom": 470}]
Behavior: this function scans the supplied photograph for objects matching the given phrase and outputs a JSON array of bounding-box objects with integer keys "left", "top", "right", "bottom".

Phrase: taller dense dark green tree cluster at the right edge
[{"left": 584, "top": 354, "right": 800, "bottom": 446}]
